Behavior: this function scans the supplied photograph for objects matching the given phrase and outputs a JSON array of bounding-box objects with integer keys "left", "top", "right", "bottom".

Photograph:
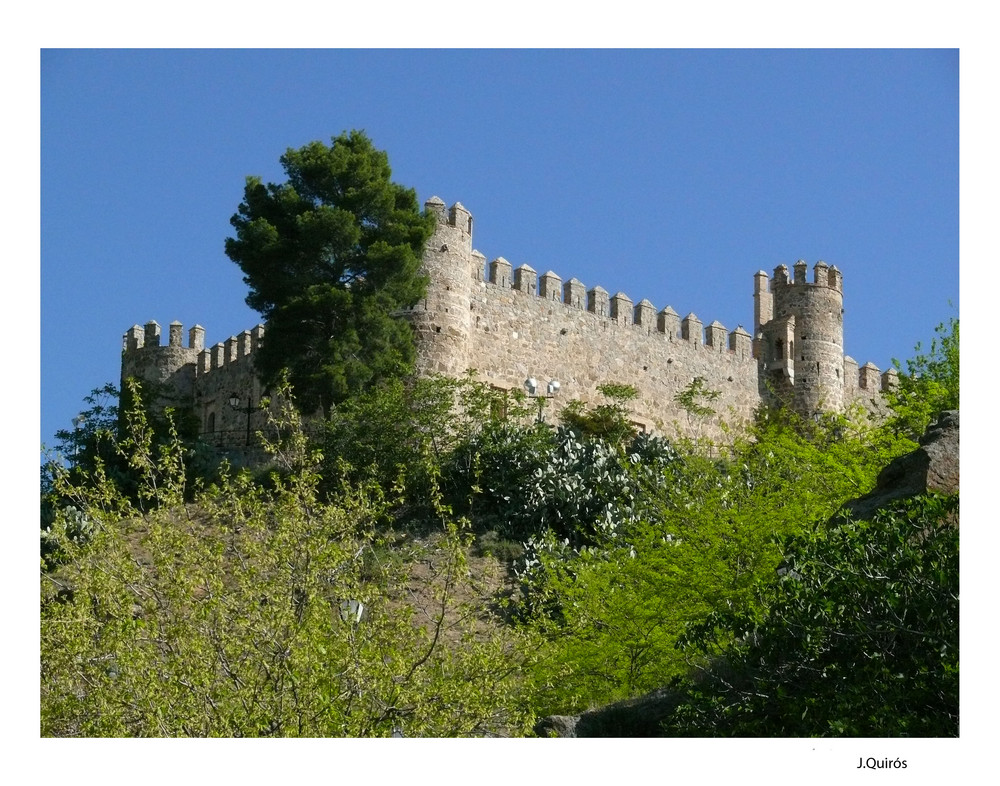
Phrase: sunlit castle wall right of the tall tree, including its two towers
[{"left": 409, "top": 197, "right": 894, "bottom": 439}]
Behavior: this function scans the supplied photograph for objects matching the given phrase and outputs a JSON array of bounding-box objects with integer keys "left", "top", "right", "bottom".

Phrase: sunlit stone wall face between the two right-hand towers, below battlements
[{"left": 469, "top": 272, "right": 760, "bottom": 438}]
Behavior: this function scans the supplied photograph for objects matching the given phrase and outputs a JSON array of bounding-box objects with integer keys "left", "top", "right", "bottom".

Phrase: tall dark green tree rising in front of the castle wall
[{"left": 226, "top": 131, "right": 434, "bottom": 414}]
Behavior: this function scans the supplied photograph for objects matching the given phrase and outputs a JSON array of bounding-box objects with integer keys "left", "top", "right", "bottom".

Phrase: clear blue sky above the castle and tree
[{"left": 40, "top": 49, "right": 959, "bottom": 445}]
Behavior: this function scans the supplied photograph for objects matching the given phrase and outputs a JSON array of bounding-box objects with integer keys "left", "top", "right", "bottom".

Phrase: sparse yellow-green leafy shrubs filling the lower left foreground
[{"left": 41, "top": 380, "right": 538, "bottom": 736}]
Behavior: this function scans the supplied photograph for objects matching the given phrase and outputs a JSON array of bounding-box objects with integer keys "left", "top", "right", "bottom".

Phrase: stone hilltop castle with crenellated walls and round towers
[{"left": 122, "top": 197, "right": 896, "bottom": 449}]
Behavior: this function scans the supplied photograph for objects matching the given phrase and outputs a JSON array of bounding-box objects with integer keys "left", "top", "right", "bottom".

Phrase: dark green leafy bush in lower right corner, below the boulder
[{"left": 666, "top": 495, "right": 958, "bottom": 737}]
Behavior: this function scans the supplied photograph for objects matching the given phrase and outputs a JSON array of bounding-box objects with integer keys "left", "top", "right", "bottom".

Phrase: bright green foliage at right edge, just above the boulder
[{"left": 889, "top": 317, "right": 959, "bottom": 440}]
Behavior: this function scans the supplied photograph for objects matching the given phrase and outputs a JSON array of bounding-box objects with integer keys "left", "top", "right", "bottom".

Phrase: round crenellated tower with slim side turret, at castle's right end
[{"left": 754, "top": 260, "right": 844, "bottom": 417}]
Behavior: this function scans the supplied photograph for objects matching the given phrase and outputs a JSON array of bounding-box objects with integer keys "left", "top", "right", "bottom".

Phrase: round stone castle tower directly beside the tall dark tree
[{"left": 409, "top": 197, "right": 483, "bottom": 376}]
